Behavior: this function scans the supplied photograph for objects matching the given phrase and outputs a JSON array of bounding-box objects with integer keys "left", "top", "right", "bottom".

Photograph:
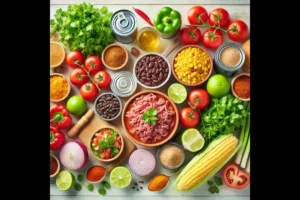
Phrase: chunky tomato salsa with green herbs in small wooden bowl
[{"left": 91, "top": 128, "right": 122, "bottom": 159}]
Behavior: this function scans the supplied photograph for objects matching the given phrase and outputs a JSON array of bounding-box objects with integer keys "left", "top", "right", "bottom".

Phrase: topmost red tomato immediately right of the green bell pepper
[{"left": 188, "top": 6, "right": 208, "bottom": 25}]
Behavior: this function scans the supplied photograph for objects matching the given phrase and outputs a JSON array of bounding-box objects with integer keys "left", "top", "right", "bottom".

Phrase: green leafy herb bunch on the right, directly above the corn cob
[{"left": 199, "top": 94, "right": 247, "bottom": 144}]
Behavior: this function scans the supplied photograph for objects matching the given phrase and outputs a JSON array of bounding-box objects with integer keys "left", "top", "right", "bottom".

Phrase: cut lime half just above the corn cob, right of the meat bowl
[{"left": 181, "top": 128, "right": 205, "bottom": 152}]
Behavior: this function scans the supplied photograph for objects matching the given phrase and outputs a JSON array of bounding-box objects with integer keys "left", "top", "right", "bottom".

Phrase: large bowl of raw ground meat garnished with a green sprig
[{"left": 122, "top": 90, "right": 179, "bottom": 147}]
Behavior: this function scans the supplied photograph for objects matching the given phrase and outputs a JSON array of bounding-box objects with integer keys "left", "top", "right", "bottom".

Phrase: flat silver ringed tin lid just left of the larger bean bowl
[{"left": 110, "top": 71, "right": 137, "bottom": 97}]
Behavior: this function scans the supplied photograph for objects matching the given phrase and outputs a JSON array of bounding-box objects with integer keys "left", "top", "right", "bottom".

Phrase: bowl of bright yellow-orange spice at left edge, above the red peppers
[{"left": 50, "top": 73, "right": 71, "bottom": 102}]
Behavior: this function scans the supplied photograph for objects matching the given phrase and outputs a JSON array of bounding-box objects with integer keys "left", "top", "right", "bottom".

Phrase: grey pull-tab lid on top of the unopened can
[{"left": 110, "top": 10, "right": 137, "bottom": 35}]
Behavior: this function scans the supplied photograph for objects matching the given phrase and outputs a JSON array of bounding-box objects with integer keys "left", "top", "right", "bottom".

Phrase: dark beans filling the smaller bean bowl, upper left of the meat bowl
[{"left": 95, "top": 94, "right": 121, "bottom": 120}]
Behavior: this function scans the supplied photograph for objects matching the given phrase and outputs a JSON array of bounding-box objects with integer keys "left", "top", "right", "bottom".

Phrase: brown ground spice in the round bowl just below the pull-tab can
[{"left": 104, "top": 46, "right": 126, "bottom": 68}]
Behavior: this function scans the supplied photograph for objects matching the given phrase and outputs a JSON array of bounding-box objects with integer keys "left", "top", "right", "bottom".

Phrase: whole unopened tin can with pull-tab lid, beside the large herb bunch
[{"left": 110, "top": 10, "right": 137, "bottom": 44}]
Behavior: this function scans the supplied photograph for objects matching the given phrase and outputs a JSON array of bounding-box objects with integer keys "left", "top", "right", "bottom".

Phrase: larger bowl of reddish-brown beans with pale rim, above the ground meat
[{"left": 133, "top": 52, "right": 171, "bottom": 89}]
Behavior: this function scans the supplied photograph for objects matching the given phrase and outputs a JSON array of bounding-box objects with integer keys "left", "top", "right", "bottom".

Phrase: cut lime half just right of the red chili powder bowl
[{"left": 110, "top": 167, "right": 132, "bottom": 188}]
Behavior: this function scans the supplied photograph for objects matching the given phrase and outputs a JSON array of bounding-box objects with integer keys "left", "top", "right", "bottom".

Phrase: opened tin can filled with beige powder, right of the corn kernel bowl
[{"left": 214, "top": 42, "right": 245, "bottom": 77}]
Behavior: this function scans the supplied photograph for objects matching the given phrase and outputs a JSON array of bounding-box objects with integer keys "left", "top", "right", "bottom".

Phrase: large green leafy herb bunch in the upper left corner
[{"left": 50, "top": 3, "right": 113, "bottom": 56}]
